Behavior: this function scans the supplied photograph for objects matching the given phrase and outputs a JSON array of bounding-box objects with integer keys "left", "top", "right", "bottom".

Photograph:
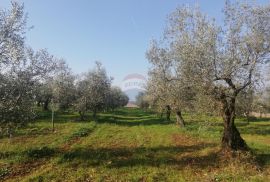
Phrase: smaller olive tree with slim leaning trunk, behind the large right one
[{"left": 147, "top": 41, "right": 195, "bottom": 127}]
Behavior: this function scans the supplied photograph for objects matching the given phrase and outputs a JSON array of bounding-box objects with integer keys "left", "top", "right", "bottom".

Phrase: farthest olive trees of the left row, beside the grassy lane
[{"left": 75, "top": 62, "right": 129, "bottom": 120}]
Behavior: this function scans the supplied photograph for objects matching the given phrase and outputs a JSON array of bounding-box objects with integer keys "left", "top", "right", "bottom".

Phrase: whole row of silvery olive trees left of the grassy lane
[{"left": 0, "top": 2, "right": 128, "bottom": 136}]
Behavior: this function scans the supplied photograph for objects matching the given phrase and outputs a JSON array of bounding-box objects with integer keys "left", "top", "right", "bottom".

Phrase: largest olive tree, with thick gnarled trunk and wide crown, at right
[{"left": 157, "top": 1, "right": 270, "bottom": 150}]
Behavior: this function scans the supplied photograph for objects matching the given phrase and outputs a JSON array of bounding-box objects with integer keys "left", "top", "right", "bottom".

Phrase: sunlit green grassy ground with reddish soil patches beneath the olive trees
[{"left": 0, "top": 109, "right": 270, "bottom": 181}]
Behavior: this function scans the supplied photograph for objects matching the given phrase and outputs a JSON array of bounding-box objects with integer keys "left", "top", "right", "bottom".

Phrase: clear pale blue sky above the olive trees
[{"left": 0, "top": 0, "right": 270, "bottom": 85}]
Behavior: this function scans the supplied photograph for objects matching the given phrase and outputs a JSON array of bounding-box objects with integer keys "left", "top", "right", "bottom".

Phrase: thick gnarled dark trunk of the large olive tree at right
[{"left": 222, "top": 97, "right": 248, "bottom": 150}]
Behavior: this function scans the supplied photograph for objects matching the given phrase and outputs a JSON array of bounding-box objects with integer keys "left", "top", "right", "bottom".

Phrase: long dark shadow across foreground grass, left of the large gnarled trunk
[{"left": 60, "top": 143, "right": 217, "bottom": 168}]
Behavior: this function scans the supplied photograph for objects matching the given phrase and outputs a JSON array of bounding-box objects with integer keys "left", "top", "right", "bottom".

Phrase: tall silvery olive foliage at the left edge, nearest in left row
[{"left": 0, "top": 2, "right": 55, "bottom": 136}]
